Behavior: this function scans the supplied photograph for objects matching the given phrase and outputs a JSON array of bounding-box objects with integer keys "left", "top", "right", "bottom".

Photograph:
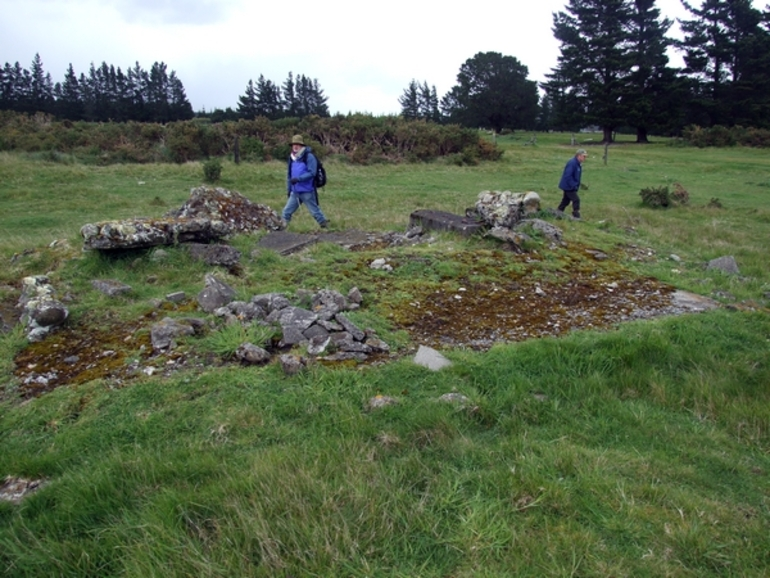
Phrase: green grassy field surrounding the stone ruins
[{"left": 0, "top": 134, "right": 770, "bottom": 577}]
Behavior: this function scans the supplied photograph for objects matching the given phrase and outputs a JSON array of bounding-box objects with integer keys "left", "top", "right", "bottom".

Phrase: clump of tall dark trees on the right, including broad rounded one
[{"left": 399, "top": 0, "right": 770, "bottom": 142}]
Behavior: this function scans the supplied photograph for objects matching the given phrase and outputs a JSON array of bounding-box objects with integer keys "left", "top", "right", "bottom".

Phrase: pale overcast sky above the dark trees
[{"left": 0, "top": 0, "right": 704, "bottom": 115}]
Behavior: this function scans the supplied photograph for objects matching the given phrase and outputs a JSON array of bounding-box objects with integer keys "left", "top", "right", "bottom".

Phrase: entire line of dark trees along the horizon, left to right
[{"left": 0, "top": 0, "right": 770, "bottom": 142}]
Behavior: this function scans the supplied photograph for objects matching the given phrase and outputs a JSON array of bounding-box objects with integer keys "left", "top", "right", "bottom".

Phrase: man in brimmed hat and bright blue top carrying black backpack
[{"left": 281, "top": 134, "right": 329, "bottom": 229}]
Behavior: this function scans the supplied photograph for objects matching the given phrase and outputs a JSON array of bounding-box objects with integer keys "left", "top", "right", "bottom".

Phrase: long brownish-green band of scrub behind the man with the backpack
[{"left": 0, "top": 111, "right": 502, "bottom": 164}]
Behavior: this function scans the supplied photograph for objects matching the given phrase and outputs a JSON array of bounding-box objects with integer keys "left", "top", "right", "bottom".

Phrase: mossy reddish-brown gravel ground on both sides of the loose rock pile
[{"left": 7, "top": 233, "right": 716, "bottom": 398}]
